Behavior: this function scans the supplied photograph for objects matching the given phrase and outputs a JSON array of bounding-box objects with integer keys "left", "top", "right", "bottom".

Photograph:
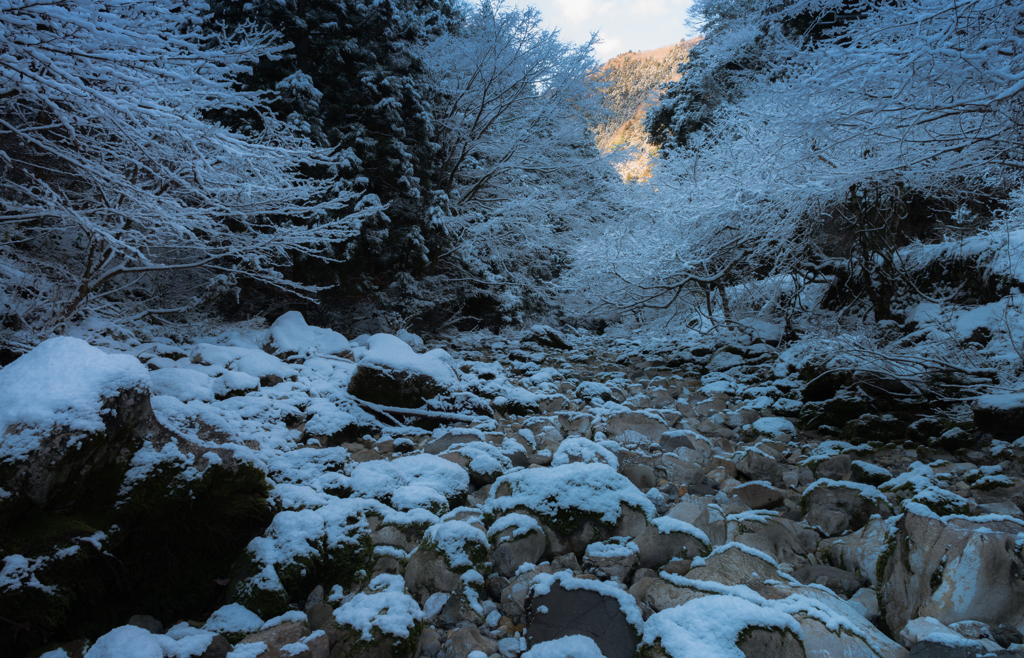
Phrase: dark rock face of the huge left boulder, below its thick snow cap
[{"left": 0, "top": 382, "right": 269, "bottom": 655}]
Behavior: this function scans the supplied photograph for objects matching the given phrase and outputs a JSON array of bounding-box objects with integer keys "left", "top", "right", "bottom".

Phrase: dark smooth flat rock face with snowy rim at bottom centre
[{"left": 526, "top": 584, "right": 640, "bottom": 658}]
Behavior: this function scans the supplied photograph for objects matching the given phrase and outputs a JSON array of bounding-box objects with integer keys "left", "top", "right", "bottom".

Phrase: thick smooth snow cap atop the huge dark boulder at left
[{"left": 0, "top": 337, "right": 150, "bottom": 462}]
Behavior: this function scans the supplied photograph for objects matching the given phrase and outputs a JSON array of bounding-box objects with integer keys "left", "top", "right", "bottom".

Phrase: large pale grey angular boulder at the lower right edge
[{"left": 879, "top": 502, "right": 1024, "bottom": 633}]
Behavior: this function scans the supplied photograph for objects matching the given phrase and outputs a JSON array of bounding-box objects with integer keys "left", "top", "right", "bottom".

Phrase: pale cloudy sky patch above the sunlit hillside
[{"left": 515, "top": 0, "right": 696, "bottom": 61}]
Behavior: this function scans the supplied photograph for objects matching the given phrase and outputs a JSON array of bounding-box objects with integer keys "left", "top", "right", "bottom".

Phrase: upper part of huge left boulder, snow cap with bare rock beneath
[{"left": 0, "top": 338, "right": 155, "bottom": 510}]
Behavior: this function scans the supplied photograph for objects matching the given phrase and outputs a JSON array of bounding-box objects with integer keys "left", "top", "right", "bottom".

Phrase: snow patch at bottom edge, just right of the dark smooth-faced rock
[{"left": 643, "top": 595, "right": 803, "bottom": 658}]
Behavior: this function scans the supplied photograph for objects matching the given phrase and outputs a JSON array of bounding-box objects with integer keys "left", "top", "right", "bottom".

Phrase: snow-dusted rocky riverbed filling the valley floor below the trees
[{"left": 0, "top": 313, "right": 1024, "bottom": 658}]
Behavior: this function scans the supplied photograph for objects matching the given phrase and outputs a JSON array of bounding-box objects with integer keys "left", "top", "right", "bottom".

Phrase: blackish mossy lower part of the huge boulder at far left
[{"left": 0, "top": 450, "right": 269, "bottom": 653}]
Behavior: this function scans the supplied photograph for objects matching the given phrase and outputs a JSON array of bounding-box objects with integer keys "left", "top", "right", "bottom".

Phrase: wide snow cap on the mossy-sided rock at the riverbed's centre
[{"left": 483, "top": 463, "right": 655, "bottom": 523}]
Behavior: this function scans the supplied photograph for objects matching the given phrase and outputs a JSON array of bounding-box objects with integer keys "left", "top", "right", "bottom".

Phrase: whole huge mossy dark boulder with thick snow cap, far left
[{"left": 0, "top": 338, "right": 269, "bottom": 653}]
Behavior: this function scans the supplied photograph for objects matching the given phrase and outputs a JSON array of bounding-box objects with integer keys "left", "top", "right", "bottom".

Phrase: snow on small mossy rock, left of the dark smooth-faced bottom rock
[{"left": 334, "top": 574, "right": 423, "bottom": 642}]
